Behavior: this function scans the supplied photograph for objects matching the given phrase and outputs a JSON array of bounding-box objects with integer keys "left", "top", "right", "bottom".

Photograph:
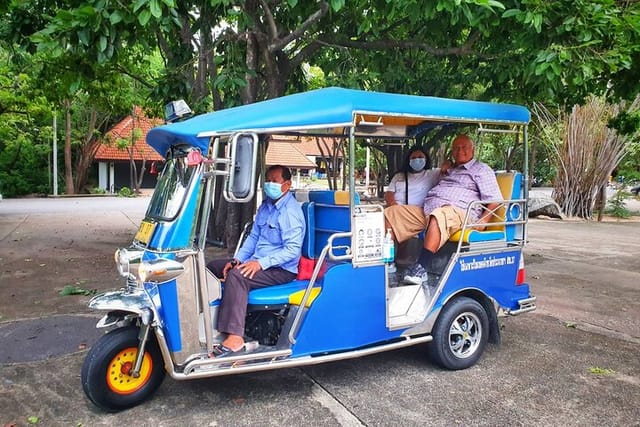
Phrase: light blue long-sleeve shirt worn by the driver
[{"left": 236, "top": 192, "right": 305, "bottom": 273}]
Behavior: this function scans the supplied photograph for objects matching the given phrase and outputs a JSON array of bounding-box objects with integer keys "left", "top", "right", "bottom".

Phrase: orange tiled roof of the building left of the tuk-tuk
[{"left": 95, "top": 107, "right": 164, "bottom": 161}]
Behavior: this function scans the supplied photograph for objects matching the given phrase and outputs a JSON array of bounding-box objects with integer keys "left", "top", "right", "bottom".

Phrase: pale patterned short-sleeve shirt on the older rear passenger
[{"left": 424, "top": 159, "right": 502, "bottom": 221}]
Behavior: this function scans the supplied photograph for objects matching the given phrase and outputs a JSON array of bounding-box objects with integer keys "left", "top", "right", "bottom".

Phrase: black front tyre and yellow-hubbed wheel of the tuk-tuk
[{"left": 81, "top": 326, "right": 165, "bottom": 412}]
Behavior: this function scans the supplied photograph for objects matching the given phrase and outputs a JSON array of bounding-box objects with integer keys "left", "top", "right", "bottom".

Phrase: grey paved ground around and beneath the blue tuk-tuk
[{"left": 0, "top": 198, "right": 640, "bottom": 426}]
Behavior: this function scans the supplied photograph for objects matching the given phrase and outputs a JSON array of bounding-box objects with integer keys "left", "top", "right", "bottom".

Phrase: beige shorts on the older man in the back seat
[{"left": 384, "top": 205, "right": 465, "bottom": 249}]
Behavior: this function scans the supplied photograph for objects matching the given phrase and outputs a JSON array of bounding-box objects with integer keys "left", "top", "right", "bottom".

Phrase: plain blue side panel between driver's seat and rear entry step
[{"left": 292, "top": 264, "right": 402, "bottom": 357}]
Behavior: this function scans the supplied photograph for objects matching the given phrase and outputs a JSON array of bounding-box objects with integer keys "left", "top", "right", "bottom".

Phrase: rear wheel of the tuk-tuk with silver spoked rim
[{"left": 428, "top": 297, "right": 489, "bottom": 370}]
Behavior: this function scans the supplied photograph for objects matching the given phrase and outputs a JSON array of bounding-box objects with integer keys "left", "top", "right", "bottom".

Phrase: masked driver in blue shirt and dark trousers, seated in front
[{"left": 207, "top": 165, "right": 305, "bottom": 357}]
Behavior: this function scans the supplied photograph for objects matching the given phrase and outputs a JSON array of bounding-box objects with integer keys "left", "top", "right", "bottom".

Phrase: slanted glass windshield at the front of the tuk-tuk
[{"left": 147, "top": 151, "right": 197, "bottom": 220}]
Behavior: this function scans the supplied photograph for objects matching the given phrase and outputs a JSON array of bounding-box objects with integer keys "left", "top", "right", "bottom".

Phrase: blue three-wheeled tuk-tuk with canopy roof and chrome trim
[{"left": 81, "top": 88, "right": 536, "bottom": 411}]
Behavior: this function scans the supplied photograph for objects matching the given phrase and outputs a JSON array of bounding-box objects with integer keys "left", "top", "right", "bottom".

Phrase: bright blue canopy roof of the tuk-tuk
[{"left": 147, "top": 87, "right": 530, "bottom": 155}]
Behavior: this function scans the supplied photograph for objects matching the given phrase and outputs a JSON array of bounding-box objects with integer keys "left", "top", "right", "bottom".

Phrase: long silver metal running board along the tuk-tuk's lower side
[{"left": 168, "top": 335, "right": 433, "bottom": 380}]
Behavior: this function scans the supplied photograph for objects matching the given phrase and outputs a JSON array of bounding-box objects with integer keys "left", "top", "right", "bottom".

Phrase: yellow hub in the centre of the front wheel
[{"left": 107, "top": 347, "right": 153, "bottom": 394}]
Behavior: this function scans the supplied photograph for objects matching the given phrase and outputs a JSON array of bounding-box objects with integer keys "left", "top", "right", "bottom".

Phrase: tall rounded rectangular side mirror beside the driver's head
[{"left": 224, "top": 133, "right": 258, "bottom": 202}]
